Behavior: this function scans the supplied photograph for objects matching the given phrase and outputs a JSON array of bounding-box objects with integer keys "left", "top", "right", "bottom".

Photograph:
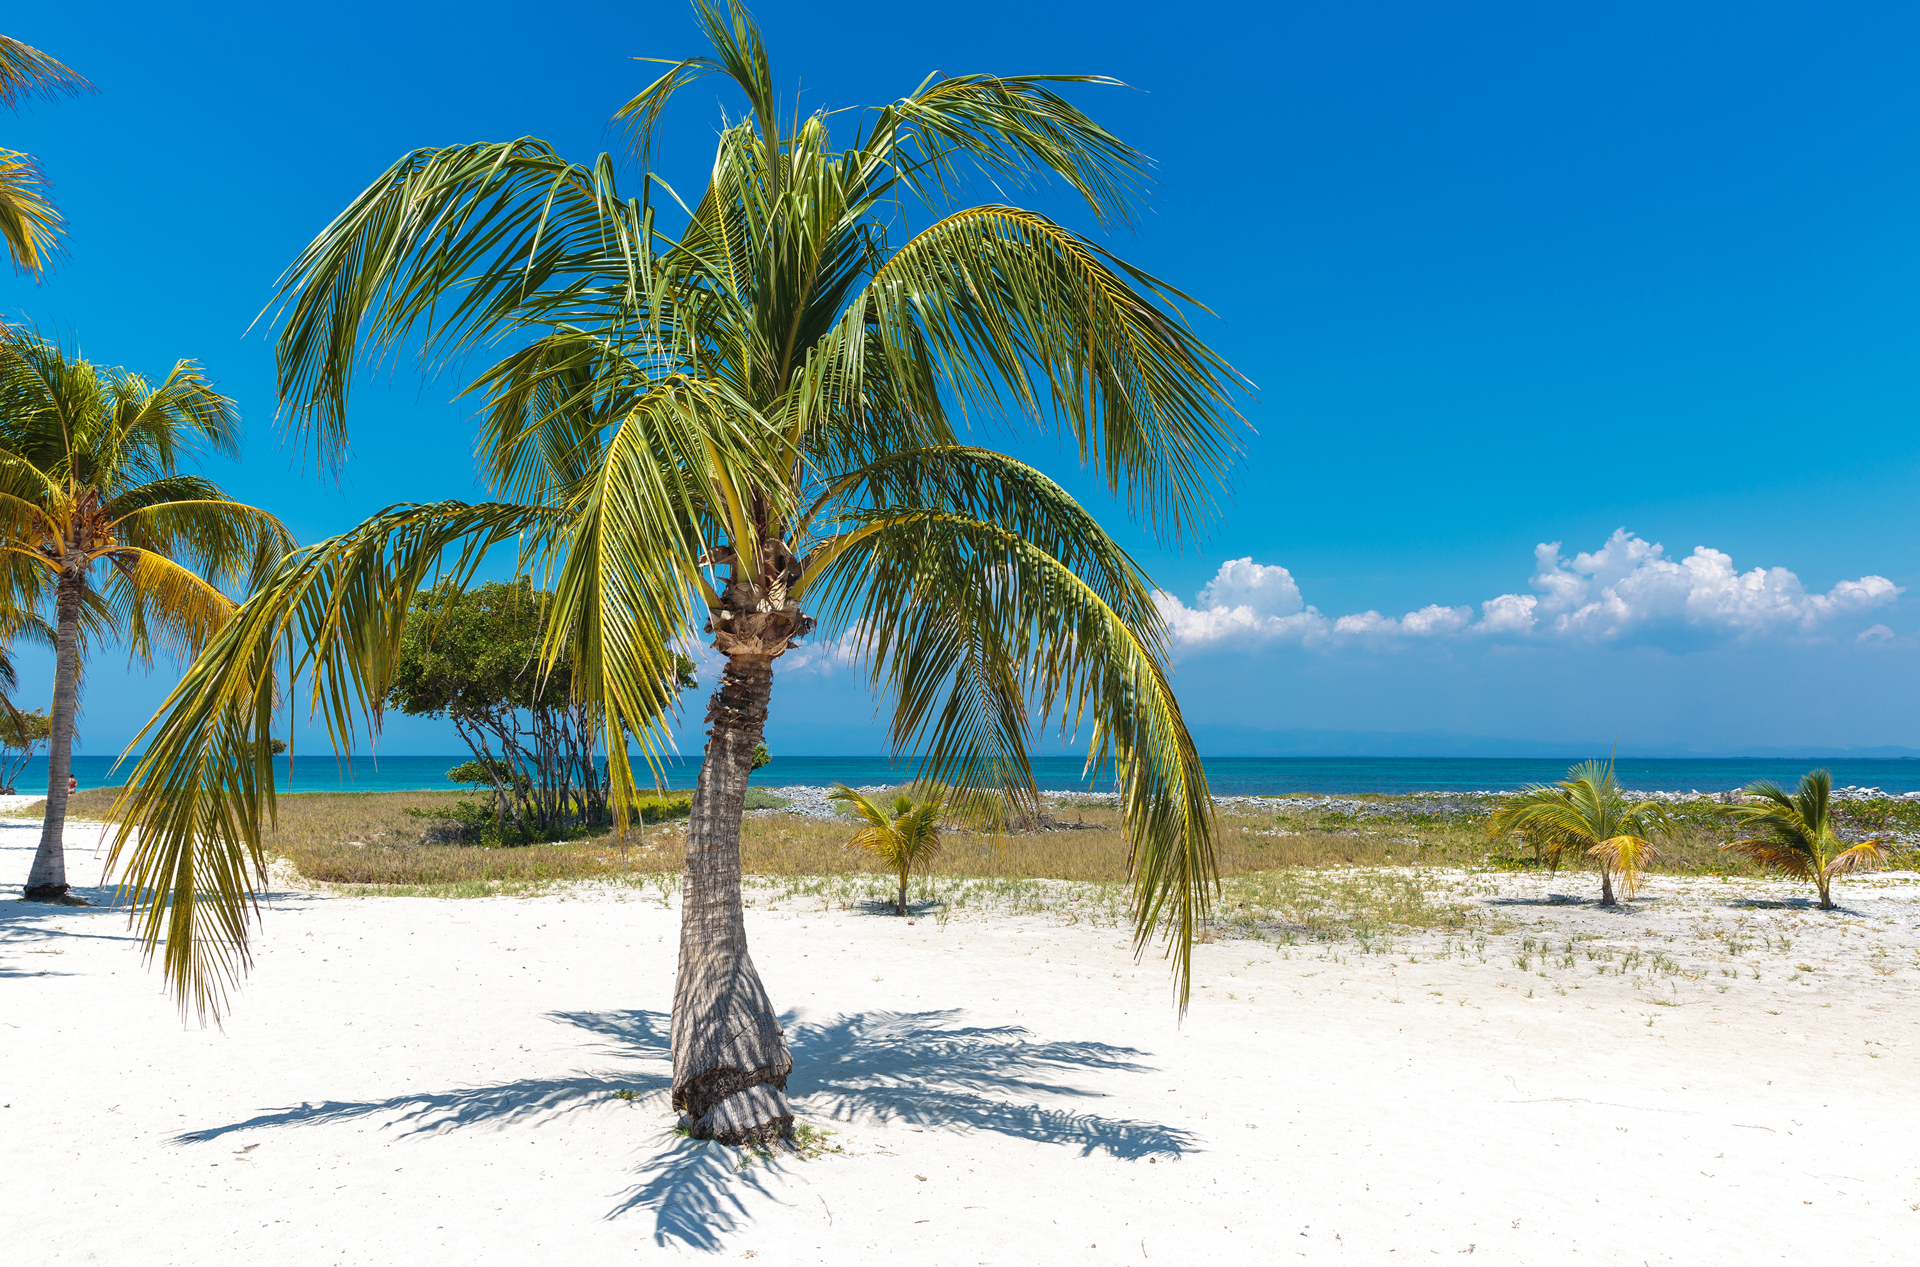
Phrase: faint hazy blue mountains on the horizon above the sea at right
[{"left": 1192, "top": 726, "right": 1920, "bottom": 760}]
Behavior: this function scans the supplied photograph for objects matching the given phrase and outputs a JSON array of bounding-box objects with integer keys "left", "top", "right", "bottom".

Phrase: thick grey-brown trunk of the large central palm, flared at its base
[{"left": 674, "top": 655, "right": 793, "bottom": 1144}]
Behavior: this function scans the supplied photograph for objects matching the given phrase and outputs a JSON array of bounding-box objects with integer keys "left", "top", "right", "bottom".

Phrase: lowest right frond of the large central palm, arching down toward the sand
[{"left": 822, "top": 505, "right": 1215, "bottom": 1000}]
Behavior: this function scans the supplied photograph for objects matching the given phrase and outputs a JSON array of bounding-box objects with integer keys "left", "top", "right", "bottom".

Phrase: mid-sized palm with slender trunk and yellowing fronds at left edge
[{"left": 0, "top": 328, "right": 292, "bottom": 904}]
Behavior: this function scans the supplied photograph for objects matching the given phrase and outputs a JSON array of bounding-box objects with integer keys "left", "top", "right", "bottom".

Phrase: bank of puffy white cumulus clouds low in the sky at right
[{"left": 1156, "top": 528, "right": 1901, "bottom": 647}]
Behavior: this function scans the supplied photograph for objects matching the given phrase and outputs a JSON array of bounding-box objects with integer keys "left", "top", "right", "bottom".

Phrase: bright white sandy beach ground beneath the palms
[{"left": 0, "top": 822, "right": 1920, "bottom": 1265}]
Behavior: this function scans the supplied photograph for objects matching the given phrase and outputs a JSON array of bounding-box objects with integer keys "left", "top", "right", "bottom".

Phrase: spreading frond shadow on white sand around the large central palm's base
[{"left": 175, "top": 1010, "right": 1198, "bottom": 1250}]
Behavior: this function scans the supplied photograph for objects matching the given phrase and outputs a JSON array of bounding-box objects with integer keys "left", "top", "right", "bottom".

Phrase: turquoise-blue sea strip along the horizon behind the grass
[{"left": 26, "top": 754, "right": 1920, "bottom": 797}]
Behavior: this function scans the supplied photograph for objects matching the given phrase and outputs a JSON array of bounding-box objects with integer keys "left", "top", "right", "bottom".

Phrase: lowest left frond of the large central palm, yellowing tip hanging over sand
[{"left": 108, "top": 503, "right": 553, "bottom": 1017}]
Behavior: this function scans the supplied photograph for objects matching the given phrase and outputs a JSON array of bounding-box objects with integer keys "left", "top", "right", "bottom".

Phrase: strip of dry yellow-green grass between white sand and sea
[{"left": 22, "top": 787, "right": 1920, "bottom": 948}]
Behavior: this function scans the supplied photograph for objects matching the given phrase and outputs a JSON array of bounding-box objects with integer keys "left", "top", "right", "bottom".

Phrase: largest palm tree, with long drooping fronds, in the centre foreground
[{"left": 108, "top": 0, "right": 1242, "bottom": 1142}]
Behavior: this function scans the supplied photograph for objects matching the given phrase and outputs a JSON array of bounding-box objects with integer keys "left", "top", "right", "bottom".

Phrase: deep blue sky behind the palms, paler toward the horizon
[{"left": 0, "top": 0, "right": 1920, "bottom": 753}]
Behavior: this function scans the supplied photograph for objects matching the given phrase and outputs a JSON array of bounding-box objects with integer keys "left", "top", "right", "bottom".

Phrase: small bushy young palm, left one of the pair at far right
[{"left": 1488, "top": 760, "right": 1672, "bottom": 906}]
